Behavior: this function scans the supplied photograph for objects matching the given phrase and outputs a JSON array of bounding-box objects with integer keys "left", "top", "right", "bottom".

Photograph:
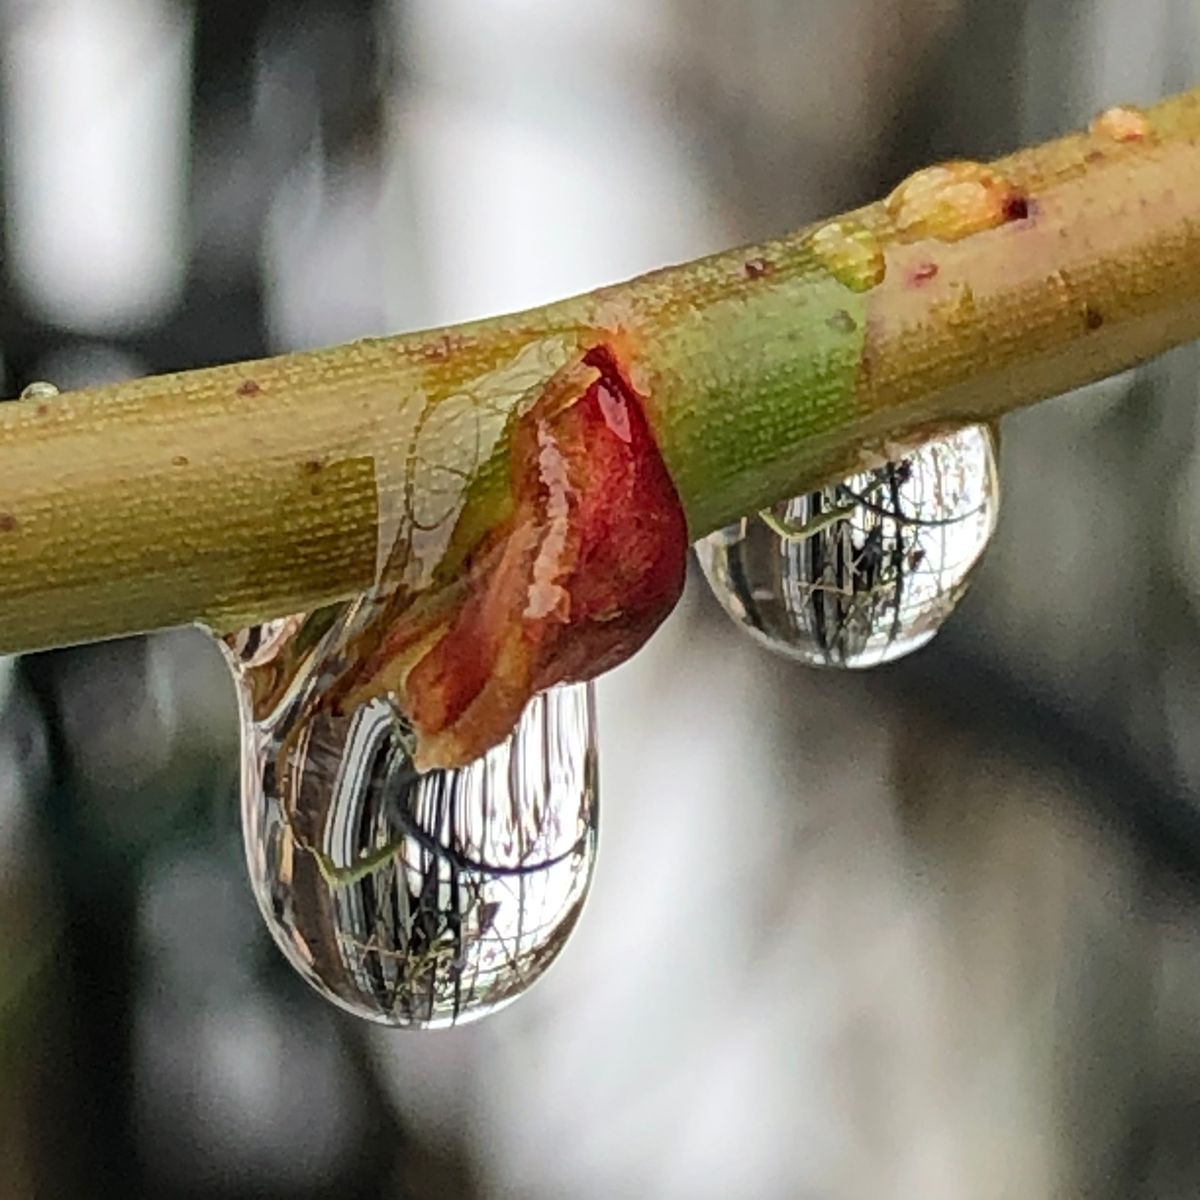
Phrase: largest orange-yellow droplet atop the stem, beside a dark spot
[{"left": 883, "top": 162, "right": 1028, "bottom": 241}]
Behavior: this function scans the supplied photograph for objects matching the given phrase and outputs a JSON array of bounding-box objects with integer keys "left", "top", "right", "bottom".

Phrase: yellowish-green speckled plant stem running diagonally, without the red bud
[{"left": 0, "top": 92, "right": 1200, "bottom": 652}]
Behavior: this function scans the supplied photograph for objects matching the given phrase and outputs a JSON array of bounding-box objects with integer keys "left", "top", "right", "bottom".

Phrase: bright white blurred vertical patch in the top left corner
[{"left": 0, "top": 0, "right": 191, "bottom": 332}]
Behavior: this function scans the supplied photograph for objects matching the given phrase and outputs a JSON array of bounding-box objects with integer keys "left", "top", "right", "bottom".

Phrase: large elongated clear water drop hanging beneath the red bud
[{"left": 224, "top": 612, "right": 598, "bottom": 1028}]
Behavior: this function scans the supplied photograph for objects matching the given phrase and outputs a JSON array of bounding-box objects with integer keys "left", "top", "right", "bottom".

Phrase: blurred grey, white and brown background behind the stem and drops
[{"left": 0, "top": 0, "right": 1200, "bottom": 1200}]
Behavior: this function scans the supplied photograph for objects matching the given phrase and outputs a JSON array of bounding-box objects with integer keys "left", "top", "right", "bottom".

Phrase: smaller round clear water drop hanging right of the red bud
[{"left": 696, "top": 425, "right": 1000, "bottom": 667}]
